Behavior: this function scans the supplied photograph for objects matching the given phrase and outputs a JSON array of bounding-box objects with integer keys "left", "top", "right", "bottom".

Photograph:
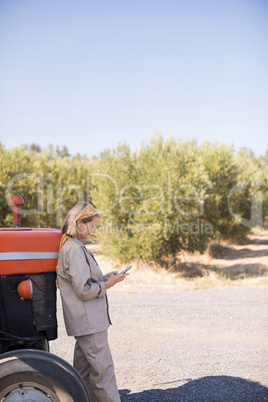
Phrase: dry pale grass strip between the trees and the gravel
[{"left": 88, "top": 232, "right": 268, "bottom": 291}]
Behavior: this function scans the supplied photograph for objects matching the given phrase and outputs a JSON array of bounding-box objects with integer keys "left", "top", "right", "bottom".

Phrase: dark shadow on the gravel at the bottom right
[{"left": 120, "top": 376, "right": 268, "bottom": 402}]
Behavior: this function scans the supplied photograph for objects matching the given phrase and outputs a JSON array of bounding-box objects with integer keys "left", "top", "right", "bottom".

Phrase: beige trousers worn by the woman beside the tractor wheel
[{"left": 73, "top": 331, "right": 120, "bottom": 402}]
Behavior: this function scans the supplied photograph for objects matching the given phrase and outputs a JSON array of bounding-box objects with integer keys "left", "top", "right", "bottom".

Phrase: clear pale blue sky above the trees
[{"left": 0, "top": 0, "right": 268, "bottom": 156}]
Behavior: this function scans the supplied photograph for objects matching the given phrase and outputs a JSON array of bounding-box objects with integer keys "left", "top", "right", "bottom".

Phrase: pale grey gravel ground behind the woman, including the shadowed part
[{"left": 50, "top": 285, "right": 268, "bottom": 402}]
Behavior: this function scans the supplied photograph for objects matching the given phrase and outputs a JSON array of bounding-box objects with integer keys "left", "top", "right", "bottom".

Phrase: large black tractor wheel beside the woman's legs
[{"left": 0, "top": 349, "right": 90, "bottom": 402}]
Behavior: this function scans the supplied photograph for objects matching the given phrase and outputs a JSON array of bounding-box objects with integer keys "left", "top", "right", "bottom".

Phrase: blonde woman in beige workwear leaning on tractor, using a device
[{"left": 58, "top": 202, "right": 127, "bottom": 402}]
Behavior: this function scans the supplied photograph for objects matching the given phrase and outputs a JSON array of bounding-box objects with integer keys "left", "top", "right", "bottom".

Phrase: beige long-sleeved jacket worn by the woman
[{"left": 58, "top": 238, "right": 111, "bottom": 336}]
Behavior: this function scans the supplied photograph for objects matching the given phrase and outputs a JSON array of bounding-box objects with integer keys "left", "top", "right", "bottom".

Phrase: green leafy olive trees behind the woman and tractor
[{"left": 0, "top": 139, "right": 268, "bottom": 261}]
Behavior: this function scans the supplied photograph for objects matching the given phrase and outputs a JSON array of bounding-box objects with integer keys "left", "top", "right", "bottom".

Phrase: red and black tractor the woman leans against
[{"left": 0, "top": 196, "right": 89, "bottom": 402}]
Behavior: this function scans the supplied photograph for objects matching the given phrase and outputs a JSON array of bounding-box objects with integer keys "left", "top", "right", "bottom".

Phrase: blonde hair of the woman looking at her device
[{"left": 61, "top": 201, "right": 99, "bottom": 237}]
